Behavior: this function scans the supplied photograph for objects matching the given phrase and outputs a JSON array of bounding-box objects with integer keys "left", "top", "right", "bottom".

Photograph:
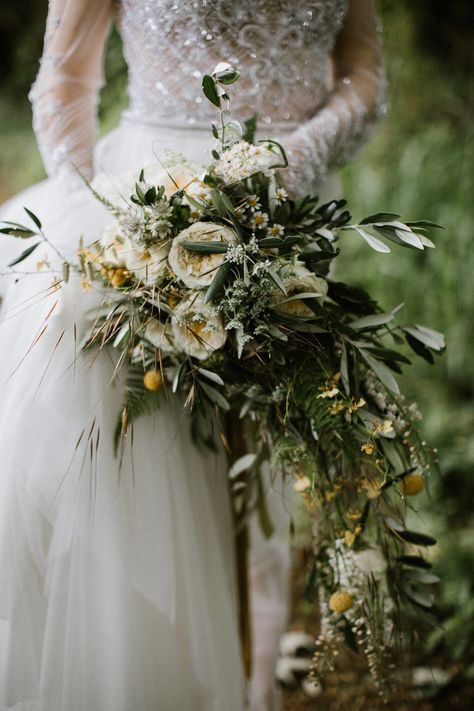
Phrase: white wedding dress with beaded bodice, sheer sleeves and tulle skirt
[{"left": 0, "top": 0, "right": 383, "bottom": 711}]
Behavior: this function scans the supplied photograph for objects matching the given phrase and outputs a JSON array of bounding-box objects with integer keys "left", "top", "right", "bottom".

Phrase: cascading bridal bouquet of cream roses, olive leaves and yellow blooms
[{"left": 3, "top": 64, "right": 444, "bottom": 693}]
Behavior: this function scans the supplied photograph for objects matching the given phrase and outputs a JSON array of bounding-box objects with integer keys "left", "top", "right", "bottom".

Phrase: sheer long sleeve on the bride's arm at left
[{"left": 30, "top": 0, "right": 112, "bottom": 178}]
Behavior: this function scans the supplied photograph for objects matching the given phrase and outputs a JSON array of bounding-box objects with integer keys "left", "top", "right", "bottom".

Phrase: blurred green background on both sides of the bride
[{"left": 0, "top": 0, "right": 474, "bottom": 700}]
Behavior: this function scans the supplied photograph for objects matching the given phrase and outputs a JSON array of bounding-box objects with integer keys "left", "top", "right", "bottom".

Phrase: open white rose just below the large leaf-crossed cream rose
[{"left": 172, "top": 294, "right": 227, "bottom": 360}]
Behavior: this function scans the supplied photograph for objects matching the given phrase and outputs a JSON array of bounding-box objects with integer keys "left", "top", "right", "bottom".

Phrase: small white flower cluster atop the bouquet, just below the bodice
[{"left": 214, "top": 141, "right": 275, "bottom": 183}]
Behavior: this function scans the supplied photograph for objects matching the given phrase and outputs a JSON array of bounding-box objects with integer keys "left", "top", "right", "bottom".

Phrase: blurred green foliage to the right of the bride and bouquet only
[{"left": 337, "top": 0, "right": 474, "bottom": 667}]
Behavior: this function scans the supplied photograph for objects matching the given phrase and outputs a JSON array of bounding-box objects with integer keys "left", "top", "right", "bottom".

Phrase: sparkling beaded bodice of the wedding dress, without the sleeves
[{"left": 118, "top": 0, "right": 348, "bottom": 124}]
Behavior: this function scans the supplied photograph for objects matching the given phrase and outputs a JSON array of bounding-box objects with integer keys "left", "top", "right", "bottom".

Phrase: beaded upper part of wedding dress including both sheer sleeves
[{"left": 31, "top": 0, "right": 383, "bottom": 190}]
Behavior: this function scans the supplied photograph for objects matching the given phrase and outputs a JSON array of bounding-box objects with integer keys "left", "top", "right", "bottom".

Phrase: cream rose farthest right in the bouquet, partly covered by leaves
[{"left": 273, "top": 262, "right": 328, "bottom": 317}]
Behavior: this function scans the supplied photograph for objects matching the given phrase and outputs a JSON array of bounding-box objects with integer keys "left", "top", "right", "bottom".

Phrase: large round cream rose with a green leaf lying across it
[{"left": 168, "top": 222, "right": 236, "bottom": 289}]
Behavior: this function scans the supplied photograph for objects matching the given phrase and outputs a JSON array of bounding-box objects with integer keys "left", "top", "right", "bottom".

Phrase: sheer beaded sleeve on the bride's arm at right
[{"left": 287, "top": 0, "right": 385, "bottom": 194}]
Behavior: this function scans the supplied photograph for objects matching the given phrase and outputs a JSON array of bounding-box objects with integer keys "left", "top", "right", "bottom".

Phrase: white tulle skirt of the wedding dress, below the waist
[{"left": 0, "top": 121, "right": 304, "bottom": 711}]
